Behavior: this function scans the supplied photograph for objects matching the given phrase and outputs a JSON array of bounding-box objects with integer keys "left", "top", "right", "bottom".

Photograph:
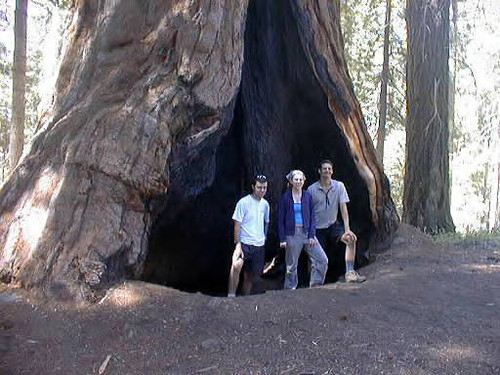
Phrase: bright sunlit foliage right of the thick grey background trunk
[{"left": 451, "top": 0, "right": 500, "bottom": 232}]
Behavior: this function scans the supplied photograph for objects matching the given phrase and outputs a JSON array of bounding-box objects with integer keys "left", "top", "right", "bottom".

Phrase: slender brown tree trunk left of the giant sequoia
[{"left": 9, "top": 0, "right": 28, "bottom": 171}]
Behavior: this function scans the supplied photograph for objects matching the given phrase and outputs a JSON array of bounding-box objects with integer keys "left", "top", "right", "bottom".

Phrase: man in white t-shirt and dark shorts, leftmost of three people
[{"left": 227, "top": 175, "right": 269, "bottom": 297}]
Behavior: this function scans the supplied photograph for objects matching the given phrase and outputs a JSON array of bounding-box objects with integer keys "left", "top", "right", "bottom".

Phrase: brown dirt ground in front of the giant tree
[{"left": 0, "top": 226, "right": 500, "bottom": 375}]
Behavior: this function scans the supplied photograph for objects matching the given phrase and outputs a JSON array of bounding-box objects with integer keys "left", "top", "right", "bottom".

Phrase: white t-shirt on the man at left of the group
[{"left": 233, "top": 194, "right": 269, "bottom": 246}]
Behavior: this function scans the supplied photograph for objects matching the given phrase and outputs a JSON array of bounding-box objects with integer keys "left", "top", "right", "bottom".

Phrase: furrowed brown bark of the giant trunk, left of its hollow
[{"left": 0, "top": 0, "right": 247, "bottom": 295}]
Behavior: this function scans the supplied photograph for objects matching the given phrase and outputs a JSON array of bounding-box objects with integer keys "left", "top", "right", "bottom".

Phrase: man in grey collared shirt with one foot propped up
[{"left": 307, "top": 160, "right": 366, "bottom": 283}]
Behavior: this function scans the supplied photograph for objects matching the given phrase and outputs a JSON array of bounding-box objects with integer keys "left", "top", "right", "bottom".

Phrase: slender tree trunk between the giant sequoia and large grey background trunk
[{"left": 377, "top": 0, "right": 392, "bottom": 166}]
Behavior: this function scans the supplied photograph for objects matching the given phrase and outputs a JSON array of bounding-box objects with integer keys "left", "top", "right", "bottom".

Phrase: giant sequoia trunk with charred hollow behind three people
[{"left": 0, "top": 0, "right": 397, "bottom": 297}]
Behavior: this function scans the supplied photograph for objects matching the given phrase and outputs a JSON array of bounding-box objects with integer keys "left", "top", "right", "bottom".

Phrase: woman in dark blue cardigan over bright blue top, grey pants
[{"left": 278, "top": 170, "right": 328, "bottom": 289}]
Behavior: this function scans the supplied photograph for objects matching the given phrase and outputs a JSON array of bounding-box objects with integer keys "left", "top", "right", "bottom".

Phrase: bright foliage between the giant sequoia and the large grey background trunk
[{"left": 341, "top": 0, "right": 406, "bottom": 212}]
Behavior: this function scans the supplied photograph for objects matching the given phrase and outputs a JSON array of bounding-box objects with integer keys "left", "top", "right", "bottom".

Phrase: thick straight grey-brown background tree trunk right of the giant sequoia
[{"left": 403, "top": 0, "right": 455, "bottom": 233}]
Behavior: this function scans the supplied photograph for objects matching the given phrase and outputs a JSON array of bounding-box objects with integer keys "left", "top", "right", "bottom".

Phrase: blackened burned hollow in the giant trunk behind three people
[{"left": 143, "top": 0, "right": 376, "bottom": 294}]
